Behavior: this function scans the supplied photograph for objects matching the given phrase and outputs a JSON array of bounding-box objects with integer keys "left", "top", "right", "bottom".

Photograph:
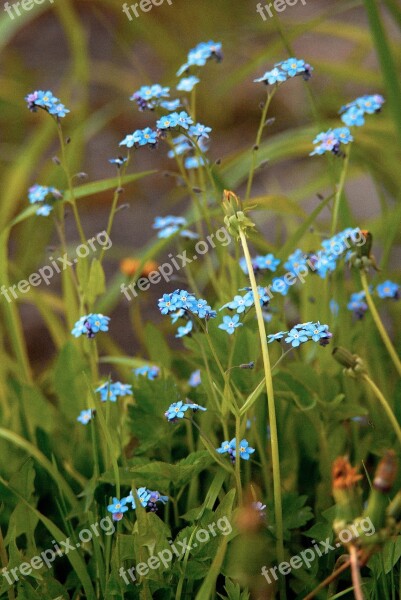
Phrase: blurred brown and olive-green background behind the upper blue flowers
[{"left": 0, "top": 0, "right": 401, "bottom": 370}]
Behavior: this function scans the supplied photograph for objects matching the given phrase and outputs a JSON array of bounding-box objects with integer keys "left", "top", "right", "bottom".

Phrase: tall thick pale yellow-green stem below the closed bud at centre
[{"left": 239, "top": 229, "right": 286, "bottom": 600}]
